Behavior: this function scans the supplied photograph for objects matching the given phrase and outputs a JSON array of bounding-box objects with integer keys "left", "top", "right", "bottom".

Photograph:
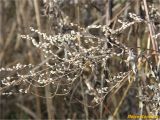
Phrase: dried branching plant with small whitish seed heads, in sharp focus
[{"left": 0, "top": 0, "right": 160, "bottom": 119}]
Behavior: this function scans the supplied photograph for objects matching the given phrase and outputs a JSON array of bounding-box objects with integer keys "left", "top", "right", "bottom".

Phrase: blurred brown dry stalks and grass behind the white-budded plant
[{"left": 0, "top": 0, "right": 160, "bottom": 119}]
